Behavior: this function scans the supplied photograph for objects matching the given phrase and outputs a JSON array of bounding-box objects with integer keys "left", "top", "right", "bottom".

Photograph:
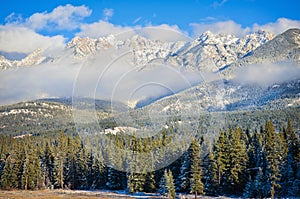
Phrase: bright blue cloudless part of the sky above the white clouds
[{"left": 0, "top": 0, "right": 300, "bottom": 38}]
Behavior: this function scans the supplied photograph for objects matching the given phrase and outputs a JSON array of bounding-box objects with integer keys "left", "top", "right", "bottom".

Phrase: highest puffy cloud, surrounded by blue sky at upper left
[{"left": 6, "top": 4, "right": 92, "bottom": 30}]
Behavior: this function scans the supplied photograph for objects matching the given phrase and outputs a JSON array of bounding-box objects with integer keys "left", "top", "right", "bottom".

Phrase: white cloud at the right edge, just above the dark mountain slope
[{"left": 252, "top": 18, "right": 300, "bottom": 34}]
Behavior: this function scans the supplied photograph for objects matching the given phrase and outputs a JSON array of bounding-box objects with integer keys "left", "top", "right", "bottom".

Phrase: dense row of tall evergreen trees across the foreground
[{"left": 0, "top": 121, "right": 300, "bottom": 198}]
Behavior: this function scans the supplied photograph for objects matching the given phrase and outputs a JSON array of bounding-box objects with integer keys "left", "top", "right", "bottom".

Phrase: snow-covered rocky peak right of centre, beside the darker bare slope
[{"left": 166, "top": 31, "right": 274, "bottom": 71}]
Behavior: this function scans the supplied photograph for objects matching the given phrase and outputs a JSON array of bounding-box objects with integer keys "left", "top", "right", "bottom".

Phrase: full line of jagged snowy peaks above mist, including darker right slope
[{"left": 0, "top": 29, "right": 300, "bottom": 74}]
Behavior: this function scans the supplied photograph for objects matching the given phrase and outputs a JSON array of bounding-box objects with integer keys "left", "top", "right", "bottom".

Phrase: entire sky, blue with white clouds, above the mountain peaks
[{"left": 0, "top": 0, "right": 300, "bottom": 54}]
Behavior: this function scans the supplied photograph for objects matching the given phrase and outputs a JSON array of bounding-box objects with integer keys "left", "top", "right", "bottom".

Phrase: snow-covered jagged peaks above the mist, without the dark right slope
[{"left": 0, "top": 31, "right": 274, "bottom": 71}]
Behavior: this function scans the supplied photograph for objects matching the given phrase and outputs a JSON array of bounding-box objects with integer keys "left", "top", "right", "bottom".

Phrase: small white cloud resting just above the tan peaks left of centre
[{"left": 76, "top": 20, "right": 132, "bottom": 38}]
